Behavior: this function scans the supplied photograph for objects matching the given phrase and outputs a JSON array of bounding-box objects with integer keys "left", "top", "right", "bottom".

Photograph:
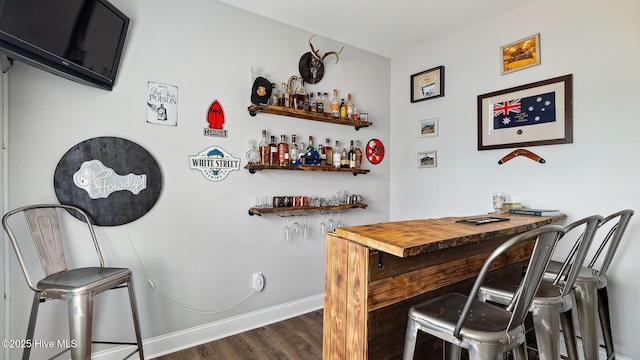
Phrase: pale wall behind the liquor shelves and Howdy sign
[{"left": 7, "top": 0, "right": 390, "bottom": 358}]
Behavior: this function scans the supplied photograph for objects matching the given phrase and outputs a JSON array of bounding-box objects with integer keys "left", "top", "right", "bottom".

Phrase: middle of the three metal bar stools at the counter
[{"left": 478, "top": 215, "right": 602, "bottom": 360}]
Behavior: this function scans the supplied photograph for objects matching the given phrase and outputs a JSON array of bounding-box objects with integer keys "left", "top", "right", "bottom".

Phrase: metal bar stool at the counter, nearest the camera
[{"left": 403, "top": 225, "right": 564, "bottom": 360}]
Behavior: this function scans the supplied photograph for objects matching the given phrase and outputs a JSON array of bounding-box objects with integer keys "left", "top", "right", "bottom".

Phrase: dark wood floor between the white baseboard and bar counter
[{"left": 156, "top": 310, "right": 322, "bottom": 360}]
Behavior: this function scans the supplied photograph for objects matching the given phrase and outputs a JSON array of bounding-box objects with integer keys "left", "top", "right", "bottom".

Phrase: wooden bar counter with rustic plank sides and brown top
[{"left": 323, "top": 213, "right": 565, "bottom": 360}]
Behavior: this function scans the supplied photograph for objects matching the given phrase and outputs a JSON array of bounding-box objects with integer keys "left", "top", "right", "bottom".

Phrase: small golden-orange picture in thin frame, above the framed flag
[{"left": 500, "top": 33, "right": 540, "bottom": 75}]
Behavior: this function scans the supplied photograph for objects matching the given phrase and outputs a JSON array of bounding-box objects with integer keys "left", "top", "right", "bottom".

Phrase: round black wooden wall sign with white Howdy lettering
[{"left": 53, "top": 137, "right": 162, "bottom": 226}]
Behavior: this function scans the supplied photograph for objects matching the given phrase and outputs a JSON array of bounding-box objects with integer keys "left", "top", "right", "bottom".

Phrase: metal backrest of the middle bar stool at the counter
[{"left": 553, "top": 215, "right": 603, "bottom": 296}]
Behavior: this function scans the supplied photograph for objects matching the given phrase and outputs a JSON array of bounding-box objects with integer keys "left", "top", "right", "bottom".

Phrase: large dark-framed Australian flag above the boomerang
[{"left": 478, "top": 74, "right": 573, "bottom": 150}]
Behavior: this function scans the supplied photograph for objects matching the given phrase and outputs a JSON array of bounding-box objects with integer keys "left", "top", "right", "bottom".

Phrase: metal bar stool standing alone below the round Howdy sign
[{"left": 2, "top": 204, "right": 144, "bottom": 360}]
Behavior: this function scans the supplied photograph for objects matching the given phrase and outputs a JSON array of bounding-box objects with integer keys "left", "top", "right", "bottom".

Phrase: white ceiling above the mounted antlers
[{"left": 220, "top": 0, "right": 534, "bottom": 59}]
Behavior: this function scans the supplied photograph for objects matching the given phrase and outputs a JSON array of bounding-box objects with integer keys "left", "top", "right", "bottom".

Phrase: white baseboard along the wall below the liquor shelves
[{"left": 91, "top": 294, "right": 324, "bottom": 360}]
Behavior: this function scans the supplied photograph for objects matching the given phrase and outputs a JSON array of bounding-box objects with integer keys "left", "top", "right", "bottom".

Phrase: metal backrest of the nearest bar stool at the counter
[{"left": 453, "top": 225, "right": 564, "bottom": 338}]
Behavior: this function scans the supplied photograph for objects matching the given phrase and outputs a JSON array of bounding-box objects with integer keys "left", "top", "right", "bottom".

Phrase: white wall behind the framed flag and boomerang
[{"left": 390, "top": 0, "right": 640, "bottom": 358}]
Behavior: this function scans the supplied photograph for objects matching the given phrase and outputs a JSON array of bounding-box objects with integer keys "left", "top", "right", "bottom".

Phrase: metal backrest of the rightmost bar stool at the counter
[{"left": 587, "top": 209, "right": 634, "bottom": 275}]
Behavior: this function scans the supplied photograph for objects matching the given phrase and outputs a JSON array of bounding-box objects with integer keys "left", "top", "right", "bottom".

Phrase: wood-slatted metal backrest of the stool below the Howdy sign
[{"left": 2, "top": 204, "right": 104, "bottom": 291}]
